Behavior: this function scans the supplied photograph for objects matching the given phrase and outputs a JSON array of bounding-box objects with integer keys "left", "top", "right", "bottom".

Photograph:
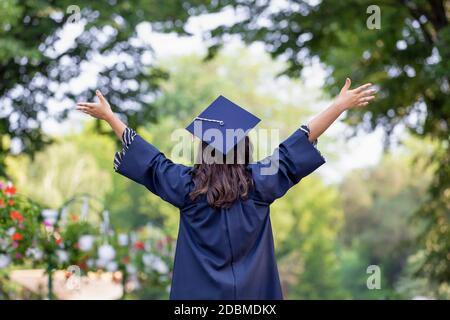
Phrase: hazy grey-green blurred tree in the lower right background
[{"left": 340, "top": 138, "right": 439, "bottom": 298}]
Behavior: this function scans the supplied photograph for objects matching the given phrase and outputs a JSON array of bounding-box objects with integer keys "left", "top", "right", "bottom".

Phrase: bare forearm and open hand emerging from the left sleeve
[{"left": 77, "top": 90, "right": 127, "bottom": 140}]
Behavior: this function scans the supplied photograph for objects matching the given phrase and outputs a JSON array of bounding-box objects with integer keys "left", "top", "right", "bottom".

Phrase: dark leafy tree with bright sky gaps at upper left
[{"left": 0, "top": 0, "right": 217, "bottom": 175}]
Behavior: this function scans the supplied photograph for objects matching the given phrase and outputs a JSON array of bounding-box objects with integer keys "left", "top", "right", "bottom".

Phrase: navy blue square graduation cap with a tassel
[{"left": 186, "top": 95, "right": 261, "bottom": 154}]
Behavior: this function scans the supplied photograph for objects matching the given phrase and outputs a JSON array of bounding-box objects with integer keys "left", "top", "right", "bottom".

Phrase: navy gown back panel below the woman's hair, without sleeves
[{"left": 174, "top": 198, "right": 282, "bottom": 299}]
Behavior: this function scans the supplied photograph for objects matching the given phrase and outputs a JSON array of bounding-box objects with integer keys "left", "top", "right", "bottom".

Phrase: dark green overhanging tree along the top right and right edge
[{"left": 195, "top": 0, "right": 450, "bottom": 288}]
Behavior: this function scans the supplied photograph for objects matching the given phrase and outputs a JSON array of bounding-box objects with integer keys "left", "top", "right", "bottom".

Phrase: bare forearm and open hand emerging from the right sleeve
[{"left": 308, "top": 78, "right": 375, "bottom": 142}]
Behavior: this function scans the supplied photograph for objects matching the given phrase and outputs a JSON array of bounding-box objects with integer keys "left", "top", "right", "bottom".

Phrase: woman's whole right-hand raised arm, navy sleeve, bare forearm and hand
[{"left": 250, "top": 78, "right": 375, "bottom": 203}]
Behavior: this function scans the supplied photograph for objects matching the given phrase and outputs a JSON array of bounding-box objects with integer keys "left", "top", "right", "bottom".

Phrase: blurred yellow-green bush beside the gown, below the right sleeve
[{"left": 271, "top": 177, "right": 345, "bottom": 299}]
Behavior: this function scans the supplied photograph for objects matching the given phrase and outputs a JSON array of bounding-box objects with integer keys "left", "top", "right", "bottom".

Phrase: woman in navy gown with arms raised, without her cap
[{"left": 77, "top": 79, "right": 375, "bottom": 300}]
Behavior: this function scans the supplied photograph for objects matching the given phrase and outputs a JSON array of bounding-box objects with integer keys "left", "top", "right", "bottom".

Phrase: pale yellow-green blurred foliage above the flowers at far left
[{"left": 7, "top": 135, "right": 114, "bottom": 208}]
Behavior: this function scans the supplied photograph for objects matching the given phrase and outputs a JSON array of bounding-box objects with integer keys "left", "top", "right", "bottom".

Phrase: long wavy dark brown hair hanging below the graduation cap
[{"left": 189, "top": 136, "right": 253, "bottom": 208}]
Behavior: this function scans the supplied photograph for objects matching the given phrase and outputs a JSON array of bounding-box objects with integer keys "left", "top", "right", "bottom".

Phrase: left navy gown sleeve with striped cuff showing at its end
[{"left": 114, "top": 128, "right": 191, "bottom": 208}]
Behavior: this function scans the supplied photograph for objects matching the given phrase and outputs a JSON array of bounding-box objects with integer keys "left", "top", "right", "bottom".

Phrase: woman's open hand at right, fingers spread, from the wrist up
[{"left": 334, "top": 78, "right": 376, "bottom": 110}]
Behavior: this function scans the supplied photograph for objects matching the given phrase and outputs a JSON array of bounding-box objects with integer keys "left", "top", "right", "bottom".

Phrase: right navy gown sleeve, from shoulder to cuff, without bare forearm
[{"left": 250, "top": 126, "right": 325, "bottom": 204}]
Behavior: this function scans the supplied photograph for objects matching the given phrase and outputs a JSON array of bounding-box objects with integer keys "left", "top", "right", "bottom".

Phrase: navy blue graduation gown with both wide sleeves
[{"left": 117, "top": 129, "right": 325, "bottom": 300}]
